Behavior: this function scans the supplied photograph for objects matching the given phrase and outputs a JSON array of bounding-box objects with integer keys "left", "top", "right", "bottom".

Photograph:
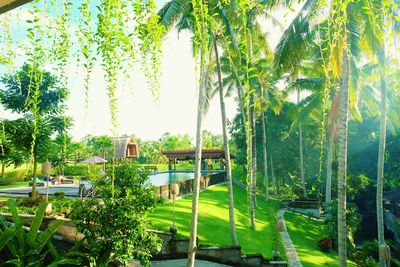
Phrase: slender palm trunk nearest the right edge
[{"left": 376, "top": 67, "right": 387, "bottom": 267}]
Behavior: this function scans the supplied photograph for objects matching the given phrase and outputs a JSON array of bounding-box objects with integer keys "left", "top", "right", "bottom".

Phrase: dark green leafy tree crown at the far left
[{"left": 0, "top": 64, "right": 71, "bottom": 168}]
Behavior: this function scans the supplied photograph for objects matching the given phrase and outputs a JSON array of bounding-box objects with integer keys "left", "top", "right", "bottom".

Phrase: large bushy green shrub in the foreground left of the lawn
[{"left": 71, "top": 164, "right": 160, "bottom": 265}]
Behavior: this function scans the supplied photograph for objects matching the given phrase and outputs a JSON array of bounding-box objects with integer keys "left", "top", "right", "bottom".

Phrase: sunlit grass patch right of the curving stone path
[{"left": 285, "top": 212, "right": 356, "bottom": 267}]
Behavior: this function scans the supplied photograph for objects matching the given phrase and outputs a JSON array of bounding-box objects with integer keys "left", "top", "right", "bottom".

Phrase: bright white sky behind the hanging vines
[{"left": 0, "top": 0, "right": 300, "bottom": 140}]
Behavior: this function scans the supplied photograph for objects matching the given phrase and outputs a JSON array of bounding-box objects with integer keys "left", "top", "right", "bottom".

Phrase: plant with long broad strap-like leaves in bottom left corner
[{"left": 0, "top": 201, "right": 81, "bottom": 266}]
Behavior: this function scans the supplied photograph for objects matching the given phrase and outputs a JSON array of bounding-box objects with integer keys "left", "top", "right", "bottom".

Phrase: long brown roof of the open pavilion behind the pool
[{"left": 161, "top": 148, "right": 233, "bottom": 160}]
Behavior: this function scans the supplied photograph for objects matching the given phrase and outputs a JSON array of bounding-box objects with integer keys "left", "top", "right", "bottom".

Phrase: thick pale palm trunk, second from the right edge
[{"left": 338, "top": 49, "right": 350, "bottom": 267}]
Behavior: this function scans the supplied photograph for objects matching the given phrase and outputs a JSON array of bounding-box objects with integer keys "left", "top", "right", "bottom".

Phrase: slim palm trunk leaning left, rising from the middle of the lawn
[{"left": 214, "top": 36, "right": 238, "bottom": 246}]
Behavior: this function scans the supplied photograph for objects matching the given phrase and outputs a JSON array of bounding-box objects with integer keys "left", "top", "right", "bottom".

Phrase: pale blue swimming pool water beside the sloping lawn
[{"left": 150, "top": 171, "right": 223, "bottom": 186}]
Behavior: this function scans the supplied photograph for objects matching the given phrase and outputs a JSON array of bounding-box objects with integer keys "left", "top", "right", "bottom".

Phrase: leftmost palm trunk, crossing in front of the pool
[{"left": 186, "top": 61, "right": 205, "bottom": 267}]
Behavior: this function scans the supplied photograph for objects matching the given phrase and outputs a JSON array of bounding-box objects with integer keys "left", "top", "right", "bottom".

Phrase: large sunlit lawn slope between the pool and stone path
[{"left": 150, "top": 185, "right": 285, "bottom": 258}]
